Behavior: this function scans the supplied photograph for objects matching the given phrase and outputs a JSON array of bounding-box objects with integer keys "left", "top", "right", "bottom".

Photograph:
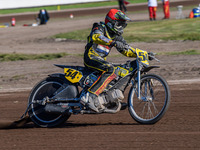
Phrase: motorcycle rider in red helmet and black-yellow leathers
[{"left": 80, "top": 9, "right": 144, "bottom": 112}]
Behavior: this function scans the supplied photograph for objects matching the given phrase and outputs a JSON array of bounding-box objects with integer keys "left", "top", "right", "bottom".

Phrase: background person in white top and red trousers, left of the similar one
[{"left": 148, "top": 0, "right": 158, "bottom": 21}]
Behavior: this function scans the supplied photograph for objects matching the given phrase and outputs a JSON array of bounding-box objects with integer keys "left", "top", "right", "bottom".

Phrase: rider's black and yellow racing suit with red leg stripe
[{"left": 84, "top": 22, "right": 136, "bottom": 96}]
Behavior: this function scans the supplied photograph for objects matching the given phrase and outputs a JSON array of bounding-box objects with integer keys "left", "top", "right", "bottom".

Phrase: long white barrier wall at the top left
[{"left": 0, "top": 0, "right": 109, "bottom": 9}]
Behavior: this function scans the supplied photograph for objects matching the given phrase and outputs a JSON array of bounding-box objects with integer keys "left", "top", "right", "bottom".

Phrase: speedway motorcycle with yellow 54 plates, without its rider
[{"left": 24, "top": 49, "right": 170, "bottom": 127}]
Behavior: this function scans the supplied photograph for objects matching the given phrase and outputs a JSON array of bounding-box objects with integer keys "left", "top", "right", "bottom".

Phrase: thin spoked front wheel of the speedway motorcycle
[{"left": 128, "top": 74, "right": 170, "bottom": 124}]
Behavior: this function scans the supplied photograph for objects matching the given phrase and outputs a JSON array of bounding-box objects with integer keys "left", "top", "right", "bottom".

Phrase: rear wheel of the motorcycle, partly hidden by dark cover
[{"left": 28, "top": 77, "right": 70, "bottom": 127}]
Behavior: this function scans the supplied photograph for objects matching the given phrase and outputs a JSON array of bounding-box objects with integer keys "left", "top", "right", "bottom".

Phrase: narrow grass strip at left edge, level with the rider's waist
[{"left": 0, "top": 53, "right": 68, "bottom": 62}]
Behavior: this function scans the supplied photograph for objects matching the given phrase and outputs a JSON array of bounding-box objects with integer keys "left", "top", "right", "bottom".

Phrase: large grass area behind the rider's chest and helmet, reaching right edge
[{"left": 53, "top": 19, "right": 200, "bottom": 42}]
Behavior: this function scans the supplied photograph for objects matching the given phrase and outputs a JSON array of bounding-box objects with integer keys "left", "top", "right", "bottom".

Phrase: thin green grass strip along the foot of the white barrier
[{"left": 0, "top": 0, "right": 147, "bottom": 14}]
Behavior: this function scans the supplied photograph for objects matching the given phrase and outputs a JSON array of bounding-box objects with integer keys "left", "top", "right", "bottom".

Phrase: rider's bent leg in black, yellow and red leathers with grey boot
[{"left": 81, "top": 48, "right": 117, "bottom": 112}]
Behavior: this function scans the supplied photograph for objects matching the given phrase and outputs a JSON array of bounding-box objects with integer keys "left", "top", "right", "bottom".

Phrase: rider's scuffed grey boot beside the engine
[{"left": 80, "top": 92, "right": 99, "bottom": 112}]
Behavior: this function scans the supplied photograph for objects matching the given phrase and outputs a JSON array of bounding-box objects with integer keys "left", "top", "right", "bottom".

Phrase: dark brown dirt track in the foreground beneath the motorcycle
[{"left": 0, "top": 84, "right": 200, "bottom": 150}]
